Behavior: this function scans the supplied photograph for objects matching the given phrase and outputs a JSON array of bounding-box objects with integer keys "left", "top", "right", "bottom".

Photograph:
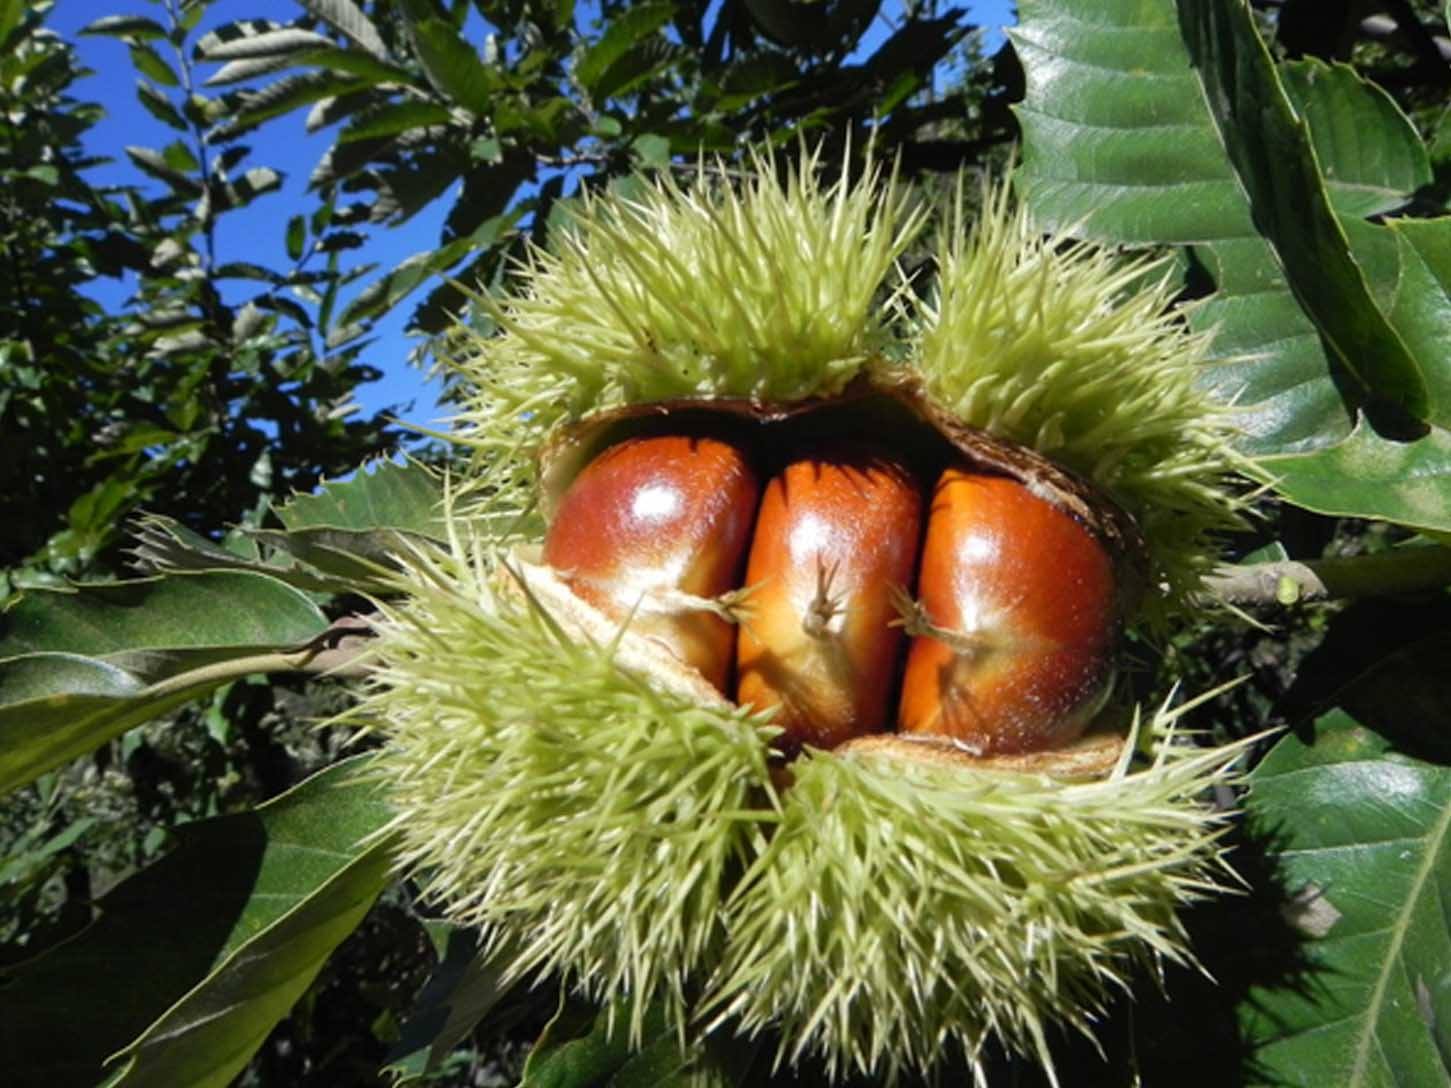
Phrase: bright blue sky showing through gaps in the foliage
[{"left": 48, "top": 0, "right": 1013, "bottom": 435}]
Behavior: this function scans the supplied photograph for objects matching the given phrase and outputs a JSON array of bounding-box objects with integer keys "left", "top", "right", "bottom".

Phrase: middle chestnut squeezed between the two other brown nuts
[{"left": 737, "top": 444, "right": 923, "bottom": 749}]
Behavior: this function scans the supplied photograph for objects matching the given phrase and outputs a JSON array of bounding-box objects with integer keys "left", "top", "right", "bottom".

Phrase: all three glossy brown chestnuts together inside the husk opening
[{"left": 543, "top": 387, "right": 1145, "bottom": 762}]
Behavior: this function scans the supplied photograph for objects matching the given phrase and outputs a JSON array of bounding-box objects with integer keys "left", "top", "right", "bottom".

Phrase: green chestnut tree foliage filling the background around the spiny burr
[{"left": 0, "top": 0, "right": 1451, "bottom": 1085}]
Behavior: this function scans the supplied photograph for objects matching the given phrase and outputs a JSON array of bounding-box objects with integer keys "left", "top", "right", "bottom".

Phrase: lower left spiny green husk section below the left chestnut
[{"left": 357, "top": 528, "right": 775, "bottom": 1031}]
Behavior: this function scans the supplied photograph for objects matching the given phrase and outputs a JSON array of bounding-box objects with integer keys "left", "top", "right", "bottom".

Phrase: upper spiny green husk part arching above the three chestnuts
[{"left": 454, "top": 155, "right": 1241, "bottom": 617}]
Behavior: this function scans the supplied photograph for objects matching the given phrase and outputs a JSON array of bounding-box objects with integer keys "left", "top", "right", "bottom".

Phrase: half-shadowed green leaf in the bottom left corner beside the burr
[{"left": 0, "top": 757, "right": 390, "bottom": 1088}]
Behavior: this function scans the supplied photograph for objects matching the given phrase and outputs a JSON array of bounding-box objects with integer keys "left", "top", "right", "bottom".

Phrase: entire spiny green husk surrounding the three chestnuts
[{"left": 368, "top": 149, "right": 1265, "bottom": 1078}]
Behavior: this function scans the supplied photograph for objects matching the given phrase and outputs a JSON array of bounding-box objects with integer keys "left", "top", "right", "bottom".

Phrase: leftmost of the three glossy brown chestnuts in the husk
[{"left": 544, "top": 434, "right": 760, "bottom": 691}]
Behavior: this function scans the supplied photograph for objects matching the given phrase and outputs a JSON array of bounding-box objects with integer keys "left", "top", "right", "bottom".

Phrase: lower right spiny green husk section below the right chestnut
[{"left": 708, "top": 709, "right": 1238, "bottom": 1081}]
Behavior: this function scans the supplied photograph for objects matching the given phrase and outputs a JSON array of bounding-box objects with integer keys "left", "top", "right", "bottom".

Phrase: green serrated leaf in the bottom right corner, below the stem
[{"left": 1242, "top": 712, "right": 1451, "bottom": 1088}]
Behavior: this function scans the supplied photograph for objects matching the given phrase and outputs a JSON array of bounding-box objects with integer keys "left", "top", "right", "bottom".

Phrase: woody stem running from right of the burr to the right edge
[{"left": 1204, "top": 545, "right": 1451, "bottom": 606}]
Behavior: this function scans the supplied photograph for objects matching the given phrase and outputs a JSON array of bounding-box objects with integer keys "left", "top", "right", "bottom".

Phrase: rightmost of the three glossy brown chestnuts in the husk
[{"left": 898, "top": 467, "right": 1120, "bottom": 754}]
